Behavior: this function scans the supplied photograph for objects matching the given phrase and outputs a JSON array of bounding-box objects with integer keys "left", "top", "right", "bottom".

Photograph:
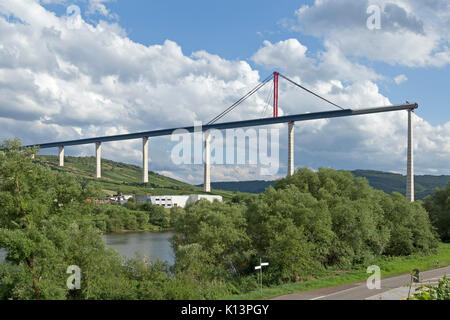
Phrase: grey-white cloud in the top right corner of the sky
[{"left": 296, "top": 0, "right": 450, "bottom": 66}]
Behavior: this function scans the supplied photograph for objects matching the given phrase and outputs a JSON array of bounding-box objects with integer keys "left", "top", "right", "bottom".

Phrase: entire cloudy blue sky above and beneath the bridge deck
[{"left": 0, "top": 0, "right": 450, "bottom": 183}]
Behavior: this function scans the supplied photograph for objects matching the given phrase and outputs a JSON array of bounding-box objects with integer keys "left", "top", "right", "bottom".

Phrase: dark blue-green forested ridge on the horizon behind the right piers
[{"left": 211, "top": 170, "right": 450, "bottom": 200}]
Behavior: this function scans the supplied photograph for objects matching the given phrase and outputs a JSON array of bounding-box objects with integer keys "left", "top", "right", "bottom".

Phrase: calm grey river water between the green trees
[{"left": 0, "top": 232, "right": 175, "bottom": 265}]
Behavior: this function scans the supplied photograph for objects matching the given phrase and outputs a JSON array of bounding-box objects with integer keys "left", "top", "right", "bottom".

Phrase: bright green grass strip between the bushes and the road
[{"left": 224, "top": 243, "right": 450, "bottom": 300}]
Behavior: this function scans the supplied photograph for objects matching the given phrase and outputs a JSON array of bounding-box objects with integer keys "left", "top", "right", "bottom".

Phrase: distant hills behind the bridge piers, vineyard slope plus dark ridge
[{"left": 36, "top": 156, "right": 450, "bottom": 200}]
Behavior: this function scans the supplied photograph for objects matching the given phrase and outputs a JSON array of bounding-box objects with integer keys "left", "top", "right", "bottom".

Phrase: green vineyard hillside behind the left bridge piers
[{"left": 36, "top": 155, "right": 239, "bottom": 199}]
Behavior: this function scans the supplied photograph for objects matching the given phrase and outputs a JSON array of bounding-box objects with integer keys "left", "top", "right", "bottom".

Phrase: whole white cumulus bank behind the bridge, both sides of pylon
[{"left": 0, "top": 0, "right": 450, "bottom": 183}]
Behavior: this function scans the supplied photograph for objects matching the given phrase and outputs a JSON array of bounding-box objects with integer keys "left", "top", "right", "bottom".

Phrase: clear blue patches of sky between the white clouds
[{"left": 40, "top": 0, "right": 450, "bottom": 125}]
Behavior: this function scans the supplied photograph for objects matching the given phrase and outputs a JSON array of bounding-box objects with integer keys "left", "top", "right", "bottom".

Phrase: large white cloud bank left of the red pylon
[{"left": 0, "top": 0, "right": 278, "bottom": 182}]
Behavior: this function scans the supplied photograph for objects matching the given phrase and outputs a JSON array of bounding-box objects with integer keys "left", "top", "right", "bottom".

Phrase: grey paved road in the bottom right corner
[{"left": 271, "top": 266, "right": 450, "bottom": 300}]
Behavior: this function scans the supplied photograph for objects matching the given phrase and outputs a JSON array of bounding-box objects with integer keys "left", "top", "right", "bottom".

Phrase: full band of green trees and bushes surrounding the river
[{"left": 0, "top": 140, "right": 448, "bottom": 299}]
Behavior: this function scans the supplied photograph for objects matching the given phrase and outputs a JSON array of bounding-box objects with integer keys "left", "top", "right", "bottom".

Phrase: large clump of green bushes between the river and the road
[{"left": 174, "top": 168, "right": 438, "bottom": 291}]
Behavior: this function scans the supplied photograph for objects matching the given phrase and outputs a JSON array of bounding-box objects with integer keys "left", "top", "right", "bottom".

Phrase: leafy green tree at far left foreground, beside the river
[{"left": 0, "top": 140, "right": 134, "bottom": 299}]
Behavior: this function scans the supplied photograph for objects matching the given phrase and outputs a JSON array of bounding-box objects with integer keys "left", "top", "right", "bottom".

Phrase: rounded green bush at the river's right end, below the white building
[{"left": 173, "top": 200, "right": 254, "bottom": 277}]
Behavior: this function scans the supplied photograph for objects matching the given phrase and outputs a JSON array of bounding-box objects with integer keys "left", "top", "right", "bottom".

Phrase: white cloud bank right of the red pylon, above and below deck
[{"left": 253, "top": 39, "right": 450, "bottom": 174}]
